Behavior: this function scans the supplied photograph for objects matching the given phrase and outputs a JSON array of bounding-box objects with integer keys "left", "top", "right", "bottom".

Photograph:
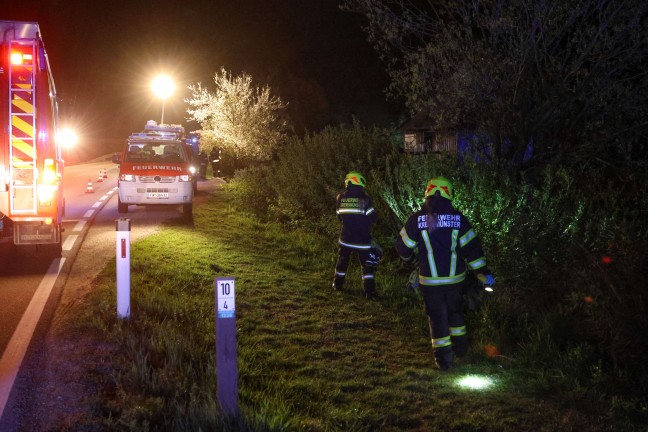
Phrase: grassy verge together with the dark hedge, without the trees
[{"left": 73, "top": 125, "right": 648, "bottom": 431}]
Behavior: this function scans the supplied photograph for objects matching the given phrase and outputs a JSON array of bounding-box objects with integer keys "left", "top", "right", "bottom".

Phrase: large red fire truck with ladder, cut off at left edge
[{"left": 0, "top": 21, "right": 65, "bottom": 252}]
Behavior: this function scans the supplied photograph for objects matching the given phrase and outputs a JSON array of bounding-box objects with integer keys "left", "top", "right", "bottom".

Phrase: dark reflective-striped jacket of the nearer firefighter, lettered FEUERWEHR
[{"left": 396, "top": 197, "right": 490, "bottom": 286}]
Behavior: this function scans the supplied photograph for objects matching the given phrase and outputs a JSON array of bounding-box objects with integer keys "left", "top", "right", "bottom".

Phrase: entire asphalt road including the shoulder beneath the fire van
[{"left": 0, "top": 161, "right": 222, "bottom": 431}]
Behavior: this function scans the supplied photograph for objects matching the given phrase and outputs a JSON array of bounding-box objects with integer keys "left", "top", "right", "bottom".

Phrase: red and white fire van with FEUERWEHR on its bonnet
[{"left": 113, "top": 120, "right": 196, "bottom": 216}]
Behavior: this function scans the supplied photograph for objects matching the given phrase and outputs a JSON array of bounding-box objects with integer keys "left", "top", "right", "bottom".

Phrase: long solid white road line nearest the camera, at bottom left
[{"left": 0, "top": 258, "right": 65, "bottom": 418}]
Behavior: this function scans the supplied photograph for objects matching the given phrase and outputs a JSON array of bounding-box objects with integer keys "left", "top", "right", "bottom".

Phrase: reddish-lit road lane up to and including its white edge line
[{"left": 0, "top": 161, "right": 117, "bottom": 422}]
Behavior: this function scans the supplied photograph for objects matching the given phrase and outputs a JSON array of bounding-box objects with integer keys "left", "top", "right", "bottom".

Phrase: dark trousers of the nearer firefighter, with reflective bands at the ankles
[{"left": 419, "top": 284, "right": 468, "bottom": 366}]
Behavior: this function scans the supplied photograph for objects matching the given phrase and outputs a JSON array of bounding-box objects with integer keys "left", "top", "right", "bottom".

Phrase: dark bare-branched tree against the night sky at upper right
[{"left": 346, "top": 0, "right": 648, "bottom": 167}]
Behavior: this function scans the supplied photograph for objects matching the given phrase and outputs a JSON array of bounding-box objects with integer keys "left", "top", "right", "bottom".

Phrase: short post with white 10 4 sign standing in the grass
[{"left": 214, "top": 277, "right": 238, "bottom": 416}]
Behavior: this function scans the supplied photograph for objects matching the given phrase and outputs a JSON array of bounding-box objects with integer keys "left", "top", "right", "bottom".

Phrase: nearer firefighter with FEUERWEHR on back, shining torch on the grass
[{"left": 396, "top": 177, "right": 495, "bottom": 371}]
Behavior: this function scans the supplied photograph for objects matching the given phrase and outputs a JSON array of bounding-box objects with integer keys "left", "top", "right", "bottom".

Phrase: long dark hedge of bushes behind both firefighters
[{"left": 227, "top": 124, "right": 648, "bottom": 412}]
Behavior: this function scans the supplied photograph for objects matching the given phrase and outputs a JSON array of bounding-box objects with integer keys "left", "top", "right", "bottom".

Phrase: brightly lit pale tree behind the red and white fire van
[{"left": 185, "top": 69, "right": 286, "bottom": 161}]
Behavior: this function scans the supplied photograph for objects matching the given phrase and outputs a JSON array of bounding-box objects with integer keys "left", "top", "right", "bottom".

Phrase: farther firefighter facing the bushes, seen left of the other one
[{"left": 333, "top": 171, "right": 382, "bottom": 299}]
